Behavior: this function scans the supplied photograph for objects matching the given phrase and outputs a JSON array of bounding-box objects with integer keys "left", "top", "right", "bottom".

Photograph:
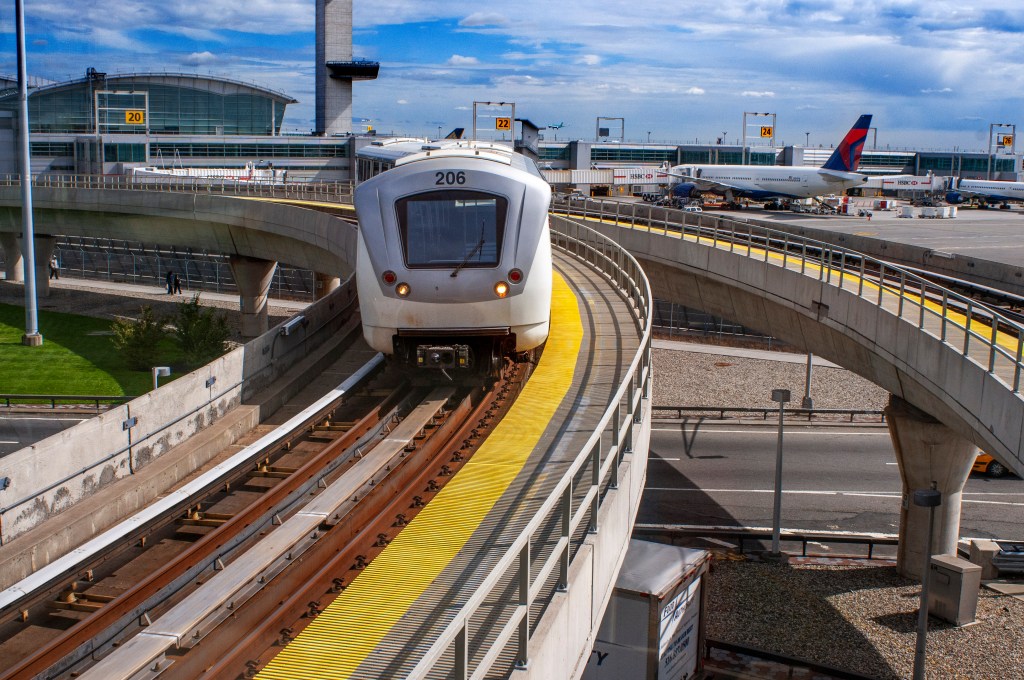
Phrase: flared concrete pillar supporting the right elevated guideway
[{"left": 886, "top": 395, "right": 978, "bottom": 579}]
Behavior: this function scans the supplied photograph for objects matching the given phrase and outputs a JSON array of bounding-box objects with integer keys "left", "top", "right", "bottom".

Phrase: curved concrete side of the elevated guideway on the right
[{"left": 591, "top": 223, "right": 1024, "bottom": 473}]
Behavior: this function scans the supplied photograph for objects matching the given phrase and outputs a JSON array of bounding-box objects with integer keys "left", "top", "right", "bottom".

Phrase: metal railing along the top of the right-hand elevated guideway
[{"left": 552, "top": 193, "right": 1024, "bottom": 393}]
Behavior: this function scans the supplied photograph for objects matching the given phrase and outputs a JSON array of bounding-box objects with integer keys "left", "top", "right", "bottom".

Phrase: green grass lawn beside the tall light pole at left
[{"left": 0, "top": 304, "right": 181, "bottom": 396}]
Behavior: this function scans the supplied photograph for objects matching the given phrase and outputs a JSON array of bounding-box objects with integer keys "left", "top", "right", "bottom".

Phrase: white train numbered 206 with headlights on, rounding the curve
[{"left": 355, "top": 140, "right": 552, "bottom": 373}]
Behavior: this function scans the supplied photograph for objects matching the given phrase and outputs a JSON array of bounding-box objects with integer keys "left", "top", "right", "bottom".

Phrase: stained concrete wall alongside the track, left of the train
[{"left": 0, "top": 280, "right": 355, "bottom": 544}]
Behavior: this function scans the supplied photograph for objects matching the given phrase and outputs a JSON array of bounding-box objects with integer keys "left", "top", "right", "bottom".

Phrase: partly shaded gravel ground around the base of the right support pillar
[{"left": 708, "top": 559, "right": 1024, "bottom": 680}]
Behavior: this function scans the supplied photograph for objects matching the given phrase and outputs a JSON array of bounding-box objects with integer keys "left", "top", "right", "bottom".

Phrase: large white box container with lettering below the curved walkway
[{"left": 583, "top": 539, "right": 711, "bottom": 680}]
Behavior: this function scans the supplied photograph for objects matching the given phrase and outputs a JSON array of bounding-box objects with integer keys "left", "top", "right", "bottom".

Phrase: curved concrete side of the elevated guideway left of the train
[{"left": 0, "top": 186, "right": 356, "bottom": 279}]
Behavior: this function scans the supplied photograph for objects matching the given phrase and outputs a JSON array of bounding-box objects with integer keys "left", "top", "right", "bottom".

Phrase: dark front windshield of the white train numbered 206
[{"left": 395, "top": 189, "right": 508, "bottom": 269}]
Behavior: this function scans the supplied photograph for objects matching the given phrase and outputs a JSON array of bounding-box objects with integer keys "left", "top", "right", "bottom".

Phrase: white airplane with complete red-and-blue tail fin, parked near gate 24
[{"left": 664, "top": 114, "right": 871, "bottom": 204}]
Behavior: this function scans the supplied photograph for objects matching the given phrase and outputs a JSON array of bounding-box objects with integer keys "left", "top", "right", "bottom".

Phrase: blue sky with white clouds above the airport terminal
[{"left": 0, "top": 0, "right": 1024, "bottom": 150}]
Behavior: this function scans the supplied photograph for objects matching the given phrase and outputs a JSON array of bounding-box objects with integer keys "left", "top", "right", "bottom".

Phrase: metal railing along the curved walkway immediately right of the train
[{"left": 408, "top": 217, "right": 653, "bottom": 680}]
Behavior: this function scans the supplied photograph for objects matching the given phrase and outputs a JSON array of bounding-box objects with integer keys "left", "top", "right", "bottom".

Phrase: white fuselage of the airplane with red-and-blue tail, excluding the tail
[{"left": 672, "top": 165, "right": 866, "bottom": 200}]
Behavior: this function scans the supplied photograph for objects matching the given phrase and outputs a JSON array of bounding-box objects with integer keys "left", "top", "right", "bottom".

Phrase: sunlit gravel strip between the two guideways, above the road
[{"left": 653, "top": 348, "right": 889, "bottom": 410}]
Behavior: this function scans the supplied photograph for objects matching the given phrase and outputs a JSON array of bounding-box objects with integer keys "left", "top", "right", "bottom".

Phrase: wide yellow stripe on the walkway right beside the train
[{"left": 257, "top": 273, "right": 583, "bottom": 680}]
